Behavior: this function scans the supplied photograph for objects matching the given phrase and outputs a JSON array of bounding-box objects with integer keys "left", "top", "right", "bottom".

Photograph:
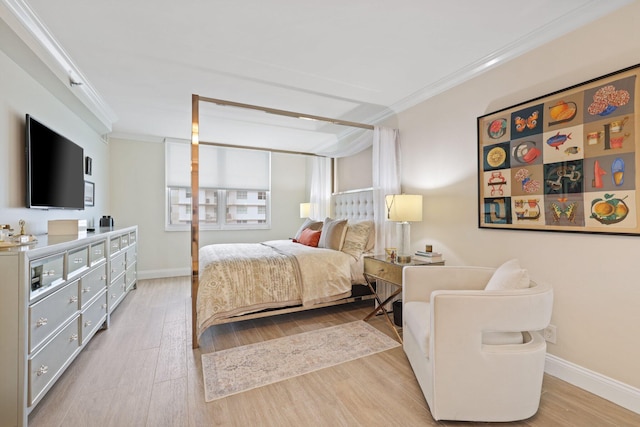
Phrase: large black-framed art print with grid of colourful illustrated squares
[{"left": 477, "top": 65, "right": 640, "bottom": 235}]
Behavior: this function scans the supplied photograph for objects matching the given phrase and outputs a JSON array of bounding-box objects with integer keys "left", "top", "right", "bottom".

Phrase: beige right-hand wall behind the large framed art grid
[{"left": 390, "top": 2, "right": 640, "bottom": 398}]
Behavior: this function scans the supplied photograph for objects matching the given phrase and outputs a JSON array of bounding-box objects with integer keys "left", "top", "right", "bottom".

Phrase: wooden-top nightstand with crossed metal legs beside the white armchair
[{"left": 364, "top": 255, "right": 444, "bottom": 342}]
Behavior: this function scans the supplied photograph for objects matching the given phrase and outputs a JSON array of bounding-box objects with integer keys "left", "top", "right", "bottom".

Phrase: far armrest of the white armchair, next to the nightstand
[{"left": 402, "top": 265, "right": 495, "bottom": 302}]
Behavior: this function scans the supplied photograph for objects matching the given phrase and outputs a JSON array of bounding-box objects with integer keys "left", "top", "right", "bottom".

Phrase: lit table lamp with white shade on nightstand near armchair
[{"left": 385, "top": 194, "right": 422, "bottom": 263}]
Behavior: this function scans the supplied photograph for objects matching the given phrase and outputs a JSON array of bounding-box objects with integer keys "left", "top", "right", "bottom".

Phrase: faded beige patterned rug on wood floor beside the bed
[{"left": 202, "top": 320, "right": 400, "bottom": 402}]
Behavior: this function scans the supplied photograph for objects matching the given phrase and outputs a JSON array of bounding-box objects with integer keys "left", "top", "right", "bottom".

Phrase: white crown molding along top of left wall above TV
[{"left": 0, "top": 0, "right": 117, "bottom": 134}]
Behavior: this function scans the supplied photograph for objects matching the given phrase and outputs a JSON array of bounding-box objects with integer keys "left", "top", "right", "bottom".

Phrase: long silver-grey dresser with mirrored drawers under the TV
[{"left": 0, "top": 226, "right": 138, "bottom": 427}]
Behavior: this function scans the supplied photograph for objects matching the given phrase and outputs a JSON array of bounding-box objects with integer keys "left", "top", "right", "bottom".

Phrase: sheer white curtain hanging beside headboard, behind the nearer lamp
[{"left": 372, "top": 127, "right": 401, "bottom": 254}]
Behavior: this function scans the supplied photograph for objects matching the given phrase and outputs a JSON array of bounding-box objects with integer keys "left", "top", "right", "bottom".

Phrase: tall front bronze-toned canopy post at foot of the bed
[{"left": 191, "top": 95, "right": 200, "bottom": 348}]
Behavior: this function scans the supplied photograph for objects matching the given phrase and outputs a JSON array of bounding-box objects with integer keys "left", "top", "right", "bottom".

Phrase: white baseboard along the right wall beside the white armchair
[{"left": 544, "top": 354, "right": 640, "bottom": 414}]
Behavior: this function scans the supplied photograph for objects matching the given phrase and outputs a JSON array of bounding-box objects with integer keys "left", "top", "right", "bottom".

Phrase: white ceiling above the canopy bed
[{"left": 2, "top": 0, "right": 630, "bottom": 152}]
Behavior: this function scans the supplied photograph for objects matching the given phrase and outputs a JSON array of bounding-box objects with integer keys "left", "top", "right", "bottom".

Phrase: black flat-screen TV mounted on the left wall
[{"left": 25, "top": 114, "right": 84, "bottom": 209}]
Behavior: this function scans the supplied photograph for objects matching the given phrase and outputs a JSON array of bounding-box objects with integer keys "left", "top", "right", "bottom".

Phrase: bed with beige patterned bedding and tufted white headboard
[{"left": 194, "top": 190, "right": 375, "bottom": 339}]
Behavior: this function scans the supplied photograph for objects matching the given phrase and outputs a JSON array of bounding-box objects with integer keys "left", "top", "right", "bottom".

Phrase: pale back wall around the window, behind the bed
[{"left": 109, "top": 138, "right": 310, "bottom": 279}]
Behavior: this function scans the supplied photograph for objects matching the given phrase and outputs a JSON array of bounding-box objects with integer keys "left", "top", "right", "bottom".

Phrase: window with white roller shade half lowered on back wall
[{"left": 165, "top": 141, "right": 271, "bottom": 230}]
